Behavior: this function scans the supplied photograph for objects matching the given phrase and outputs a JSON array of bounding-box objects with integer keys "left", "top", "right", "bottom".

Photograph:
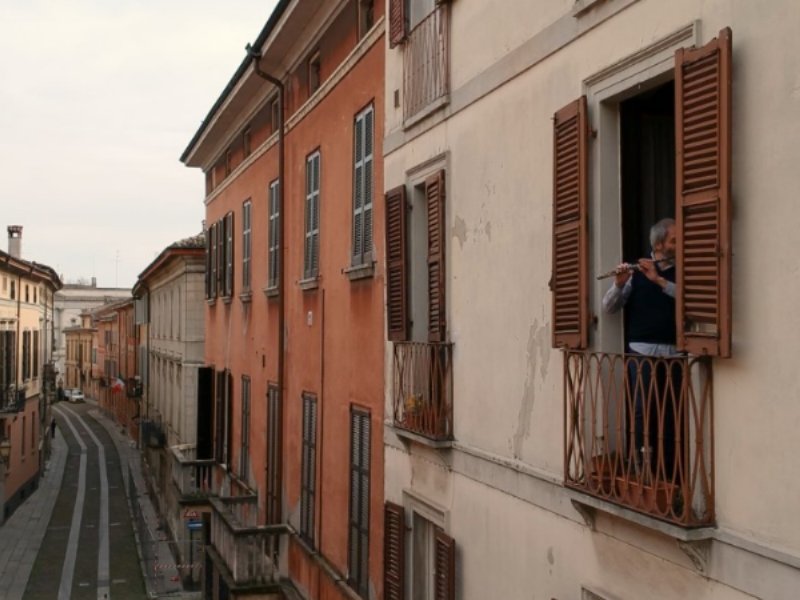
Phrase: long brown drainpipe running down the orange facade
[{"left": 245, "top": 44, "right": 286, "bottom": 515}]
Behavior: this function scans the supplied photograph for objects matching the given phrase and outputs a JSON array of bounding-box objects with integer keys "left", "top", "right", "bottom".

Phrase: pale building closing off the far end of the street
[{"left": 53, "top": 277, "right": 131, "bottom": 385}]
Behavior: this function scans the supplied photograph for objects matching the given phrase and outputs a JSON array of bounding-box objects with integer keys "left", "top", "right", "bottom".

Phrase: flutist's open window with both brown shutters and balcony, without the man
[{"left": 551, "top": 26, "right": 731, "bottom": 526}]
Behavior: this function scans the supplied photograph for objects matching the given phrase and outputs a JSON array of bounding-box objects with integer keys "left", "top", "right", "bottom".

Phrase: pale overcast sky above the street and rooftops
[{"left": 0, "top": 0, "right": 275, "bottom": 287}]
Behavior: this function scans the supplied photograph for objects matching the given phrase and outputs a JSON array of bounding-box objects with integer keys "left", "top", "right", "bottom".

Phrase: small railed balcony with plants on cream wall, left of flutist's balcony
[{"left": 393, "top": 342, "right": 453, "bottom": 442}]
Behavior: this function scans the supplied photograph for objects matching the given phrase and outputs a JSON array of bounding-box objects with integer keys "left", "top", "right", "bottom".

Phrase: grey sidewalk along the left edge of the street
[{"left": 0, "top": 431, "right": 68, "bottom": 600}]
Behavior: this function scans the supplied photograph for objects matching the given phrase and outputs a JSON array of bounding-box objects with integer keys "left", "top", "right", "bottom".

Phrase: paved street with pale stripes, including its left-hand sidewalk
[{"left": 0, "top": 403, "right": 153, "bottom": 600}]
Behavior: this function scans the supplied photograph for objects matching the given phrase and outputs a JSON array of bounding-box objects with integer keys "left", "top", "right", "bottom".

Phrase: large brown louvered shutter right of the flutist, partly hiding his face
[{"left": 675, "top": 28, "right": 731, "bottom": 357}]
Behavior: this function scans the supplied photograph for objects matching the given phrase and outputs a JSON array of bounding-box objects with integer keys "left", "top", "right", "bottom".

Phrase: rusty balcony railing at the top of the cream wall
[{"left": 403, "top": 4, "right": 450, "bottom": 121}]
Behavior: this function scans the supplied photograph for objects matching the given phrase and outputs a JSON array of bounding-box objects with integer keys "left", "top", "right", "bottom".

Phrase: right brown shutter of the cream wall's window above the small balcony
[{"left": 425, "top": 170, "right": 447, "bottom": 342}]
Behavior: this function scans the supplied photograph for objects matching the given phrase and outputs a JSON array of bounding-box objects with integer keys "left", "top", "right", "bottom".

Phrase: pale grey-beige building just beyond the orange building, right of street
[{"left": 129, "top": 234, "right": 205, "bottom": 582}]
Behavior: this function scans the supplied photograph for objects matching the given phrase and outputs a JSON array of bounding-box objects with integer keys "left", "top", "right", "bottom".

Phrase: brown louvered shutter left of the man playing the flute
[{"left": 550, "top": 96, "right": 588, "bottom": 348}]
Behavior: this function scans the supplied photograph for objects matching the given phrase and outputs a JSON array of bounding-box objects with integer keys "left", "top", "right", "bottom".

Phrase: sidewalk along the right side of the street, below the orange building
[{"left": 86, "top": 398, "right": 186, "bottom": 598}]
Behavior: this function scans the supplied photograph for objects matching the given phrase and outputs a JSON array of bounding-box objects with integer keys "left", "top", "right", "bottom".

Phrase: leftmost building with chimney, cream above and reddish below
[{"left": 0, "top": 225, "right": 61, "bottom": 523}]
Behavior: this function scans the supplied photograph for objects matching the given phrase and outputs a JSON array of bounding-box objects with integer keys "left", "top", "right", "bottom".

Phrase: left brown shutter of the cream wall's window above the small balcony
[{"left": 386, "top": 185, "right": 408, "bottom": 342}]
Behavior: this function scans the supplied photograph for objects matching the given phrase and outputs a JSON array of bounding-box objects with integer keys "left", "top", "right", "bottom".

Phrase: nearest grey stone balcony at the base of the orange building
[{"left": 210, "top": 494, "right": 283, "bottom": 588}]
